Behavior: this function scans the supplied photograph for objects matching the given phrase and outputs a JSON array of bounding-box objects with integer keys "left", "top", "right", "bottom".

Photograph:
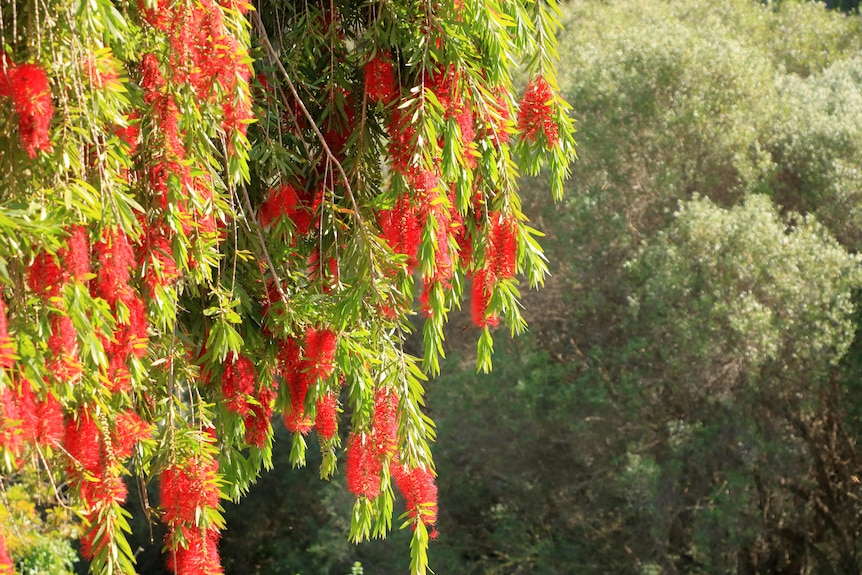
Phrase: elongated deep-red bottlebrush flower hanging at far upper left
[{"left": 9, "top": 64, "right": 54, "bottom": 158}]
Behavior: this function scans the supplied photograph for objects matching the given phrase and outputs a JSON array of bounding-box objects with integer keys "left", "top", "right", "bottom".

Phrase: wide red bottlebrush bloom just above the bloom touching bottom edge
[{"left": 159, "top": 457, "right": 219, "bottom": 527}]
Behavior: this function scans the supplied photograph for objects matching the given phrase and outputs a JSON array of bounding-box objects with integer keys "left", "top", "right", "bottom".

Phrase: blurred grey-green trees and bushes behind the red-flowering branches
[{"left": 8, "top": 0, "right": 862, "bottom": 575}]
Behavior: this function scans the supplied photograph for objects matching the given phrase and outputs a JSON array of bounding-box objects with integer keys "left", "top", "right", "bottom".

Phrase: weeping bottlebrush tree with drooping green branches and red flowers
[{"left": 0, "top": 0, "right": 574, "bottom": 575}]
